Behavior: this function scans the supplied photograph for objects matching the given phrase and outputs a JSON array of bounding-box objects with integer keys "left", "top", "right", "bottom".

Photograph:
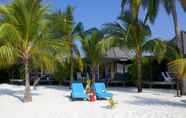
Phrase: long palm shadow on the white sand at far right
[{"left": 129, "top": 96, "right": 186, "bottom": 108}]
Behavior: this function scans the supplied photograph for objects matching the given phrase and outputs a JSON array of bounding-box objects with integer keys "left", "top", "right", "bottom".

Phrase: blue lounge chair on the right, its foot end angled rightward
[{"left": 92, "top": 82, "right": 113, "bottom": 100}]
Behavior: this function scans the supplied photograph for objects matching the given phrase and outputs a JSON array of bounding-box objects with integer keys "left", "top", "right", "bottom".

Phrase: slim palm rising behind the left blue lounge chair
[{"left": 49, "top": 6, "right": 83, "bottom": 81}]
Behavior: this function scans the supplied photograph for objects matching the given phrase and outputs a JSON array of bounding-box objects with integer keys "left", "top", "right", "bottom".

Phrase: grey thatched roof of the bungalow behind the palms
[{"left": 102, "top": 47, "right": 130, "bottom": 61}]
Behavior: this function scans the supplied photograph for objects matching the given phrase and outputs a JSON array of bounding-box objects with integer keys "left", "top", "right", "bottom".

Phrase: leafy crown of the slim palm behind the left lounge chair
[{"left": 48, "top": 6, "right": 76, "bottom": 40}]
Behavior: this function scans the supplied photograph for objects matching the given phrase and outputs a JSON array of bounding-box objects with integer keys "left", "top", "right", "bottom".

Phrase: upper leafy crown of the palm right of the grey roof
[{"left": 104, "top": 11, "right": 151, "bottom": 49}]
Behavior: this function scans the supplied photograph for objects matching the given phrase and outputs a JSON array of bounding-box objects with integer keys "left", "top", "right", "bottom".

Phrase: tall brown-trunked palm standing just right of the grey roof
[{"left": 102, "top": 11, "right": 166, "bottom": 92}]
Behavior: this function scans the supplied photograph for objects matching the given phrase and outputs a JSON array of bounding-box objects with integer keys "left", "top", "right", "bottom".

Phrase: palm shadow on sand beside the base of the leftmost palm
[{"left": 0, "top": 89, "right": 38, "bottom": 102}]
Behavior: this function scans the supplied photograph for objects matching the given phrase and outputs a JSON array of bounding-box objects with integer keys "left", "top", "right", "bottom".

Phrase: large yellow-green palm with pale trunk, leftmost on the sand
[{"left": 0, "top": 0, "right": 66, "bottom": 102}]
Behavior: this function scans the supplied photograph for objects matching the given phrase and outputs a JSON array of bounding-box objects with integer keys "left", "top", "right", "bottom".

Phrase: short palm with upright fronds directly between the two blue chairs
[{"left": 81, "top": 28, "right": 105, "bottom": 82}]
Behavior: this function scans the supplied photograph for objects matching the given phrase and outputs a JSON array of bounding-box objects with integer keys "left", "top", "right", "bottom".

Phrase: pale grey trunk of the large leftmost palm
[{"left": 23, "top": 59, "right": 32, "bottom": 102}]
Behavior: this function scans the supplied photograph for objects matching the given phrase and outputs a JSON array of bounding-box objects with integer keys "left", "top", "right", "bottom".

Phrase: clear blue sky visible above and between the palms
[{"left": 0, "top": 0, "right": 186, "bottom": 40}]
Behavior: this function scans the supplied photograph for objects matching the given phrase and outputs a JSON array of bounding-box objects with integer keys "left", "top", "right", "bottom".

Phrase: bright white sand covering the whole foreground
[{"left": 0, "top": 84, "right": 186, "bottom": 118}]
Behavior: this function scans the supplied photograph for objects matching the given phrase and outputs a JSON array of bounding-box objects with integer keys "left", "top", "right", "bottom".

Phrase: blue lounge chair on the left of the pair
[{"left": 71, "top": 83, "right": 88, "bottom": 100}]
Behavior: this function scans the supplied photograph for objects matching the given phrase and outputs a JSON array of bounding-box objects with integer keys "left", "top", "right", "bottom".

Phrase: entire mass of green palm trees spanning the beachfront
[{"left": 0, "top": 0, "right": 186, "bottom": 102}]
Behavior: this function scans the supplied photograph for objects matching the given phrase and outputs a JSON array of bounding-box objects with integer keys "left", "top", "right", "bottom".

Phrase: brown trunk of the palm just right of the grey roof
[{"left": 136, "top": 51, "right": 142, "bottom": 93}]
